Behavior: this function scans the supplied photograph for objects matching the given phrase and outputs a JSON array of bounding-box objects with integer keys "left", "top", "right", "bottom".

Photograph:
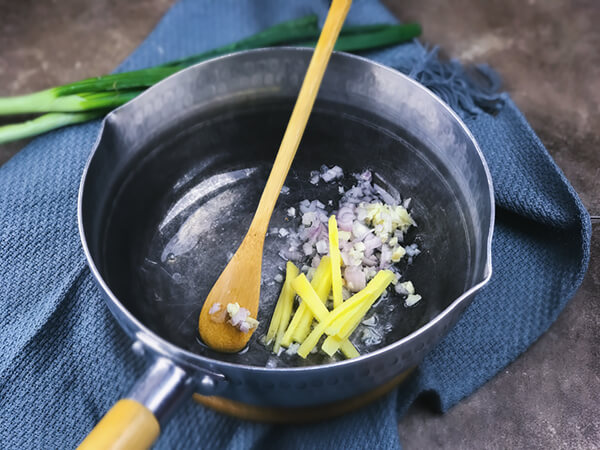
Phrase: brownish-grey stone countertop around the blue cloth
[{"left": 0, "top": 0, "right": 600, "bottom": 450}]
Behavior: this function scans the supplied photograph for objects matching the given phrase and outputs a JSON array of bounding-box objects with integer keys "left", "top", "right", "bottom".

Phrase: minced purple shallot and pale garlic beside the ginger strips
[{"left": 280, "top": 166, "right": 420, "bottom": 301}]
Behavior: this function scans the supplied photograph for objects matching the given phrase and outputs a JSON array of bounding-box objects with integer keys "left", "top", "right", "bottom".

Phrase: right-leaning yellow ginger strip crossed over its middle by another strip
[{"left": 281, "top": 256, "right": 331, "bottom": 347}]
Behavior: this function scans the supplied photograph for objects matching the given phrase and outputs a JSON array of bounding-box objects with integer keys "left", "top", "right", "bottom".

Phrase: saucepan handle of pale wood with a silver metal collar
[{"left": 78, "top": 358, "right": 193, "bottom": 450}]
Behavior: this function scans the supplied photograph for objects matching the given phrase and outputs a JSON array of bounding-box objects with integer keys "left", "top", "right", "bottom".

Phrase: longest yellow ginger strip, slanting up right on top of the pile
[{"left": 298, "top": 270, "right": 394, "bottom": 358}]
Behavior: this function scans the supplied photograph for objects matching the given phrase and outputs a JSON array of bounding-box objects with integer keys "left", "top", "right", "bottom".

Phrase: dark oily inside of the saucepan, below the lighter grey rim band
[{"left": 99, "top": 102, "right": 474, "bottom": 367}]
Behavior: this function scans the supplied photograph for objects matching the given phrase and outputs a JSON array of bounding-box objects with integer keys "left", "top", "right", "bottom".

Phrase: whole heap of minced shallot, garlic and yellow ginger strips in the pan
[{"left": 266, "top": 166, "right": 421, "bottom": 358}]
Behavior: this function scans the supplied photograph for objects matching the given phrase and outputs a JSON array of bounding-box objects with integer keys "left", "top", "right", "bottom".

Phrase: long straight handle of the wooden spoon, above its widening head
[{"left": 250, "top": 0, "right": 352, "bottom": 235}]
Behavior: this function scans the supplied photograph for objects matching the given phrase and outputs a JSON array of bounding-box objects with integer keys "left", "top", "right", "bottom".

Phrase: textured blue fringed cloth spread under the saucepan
[{"left": 0, "top": 0, "right": 591, "bottom": 449}]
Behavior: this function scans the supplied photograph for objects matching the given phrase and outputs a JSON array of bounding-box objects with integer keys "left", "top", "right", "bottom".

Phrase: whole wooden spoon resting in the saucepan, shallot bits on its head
[{"left": 198, "top": 0, "right": 352, "bottom": 353}]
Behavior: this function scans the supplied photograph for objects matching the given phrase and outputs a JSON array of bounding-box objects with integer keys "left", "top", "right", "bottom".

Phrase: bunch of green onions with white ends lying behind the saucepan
[{"left": 0, "top": 15, "right": 421, "bottom": 143}]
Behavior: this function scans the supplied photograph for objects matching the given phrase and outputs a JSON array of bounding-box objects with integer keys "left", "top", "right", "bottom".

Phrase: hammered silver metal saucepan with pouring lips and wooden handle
[{"left": 79, "top": 48, "right": 494, "bottom": 445}]
